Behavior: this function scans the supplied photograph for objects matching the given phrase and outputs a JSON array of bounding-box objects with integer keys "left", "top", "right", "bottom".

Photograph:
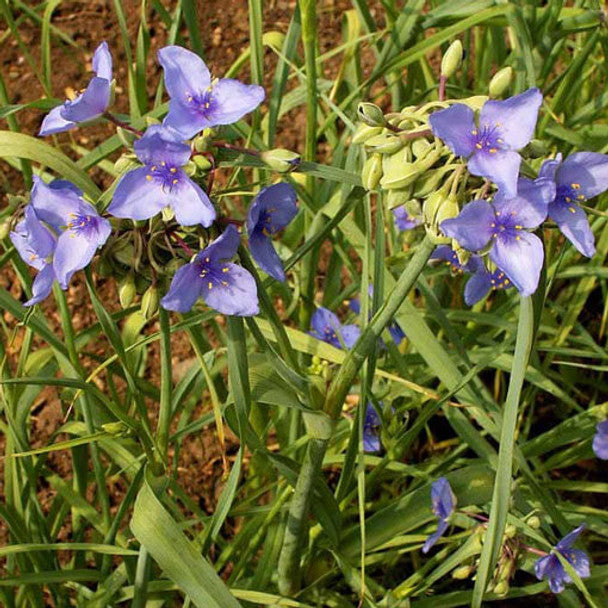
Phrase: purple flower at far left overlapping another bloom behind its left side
[{"left": 31, "top": 178, "right": 112, "bottom": 289}]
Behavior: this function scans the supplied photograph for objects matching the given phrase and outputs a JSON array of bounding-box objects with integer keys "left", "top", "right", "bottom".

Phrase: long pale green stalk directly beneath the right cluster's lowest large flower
[{"left": 471, "top": 297, "right": 534, "bottom": 608}]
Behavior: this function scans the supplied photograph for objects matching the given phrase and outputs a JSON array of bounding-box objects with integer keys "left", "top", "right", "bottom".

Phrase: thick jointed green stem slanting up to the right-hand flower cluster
[{"left": 278, "top": 237, "right": 435, "bottom": 597}]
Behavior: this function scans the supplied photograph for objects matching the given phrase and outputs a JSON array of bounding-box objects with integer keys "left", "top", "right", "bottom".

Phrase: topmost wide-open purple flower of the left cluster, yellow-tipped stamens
[{"left": 158, "top": 46, "right": 265, "bottom": 139}]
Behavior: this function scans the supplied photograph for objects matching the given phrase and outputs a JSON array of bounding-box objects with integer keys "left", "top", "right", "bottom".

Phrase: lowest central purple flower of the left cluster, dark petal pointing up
[{"left": 161, "top": 224, "right": 259, "bottom": 317}]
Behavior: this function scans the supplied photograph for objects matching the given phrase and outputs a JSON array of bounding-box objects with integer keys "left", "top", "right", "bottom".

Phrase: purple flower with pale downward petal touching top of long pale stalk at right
[{"left": 441, "top": 178, "right": 555, "bottom": 296}]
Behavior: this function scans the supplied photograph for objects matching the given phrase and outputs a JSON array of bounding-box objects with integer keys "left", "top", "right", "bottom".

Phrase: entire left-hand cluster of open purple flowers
[{"left": 11, "top": 42, "right": 300, "bottom": 318}]
